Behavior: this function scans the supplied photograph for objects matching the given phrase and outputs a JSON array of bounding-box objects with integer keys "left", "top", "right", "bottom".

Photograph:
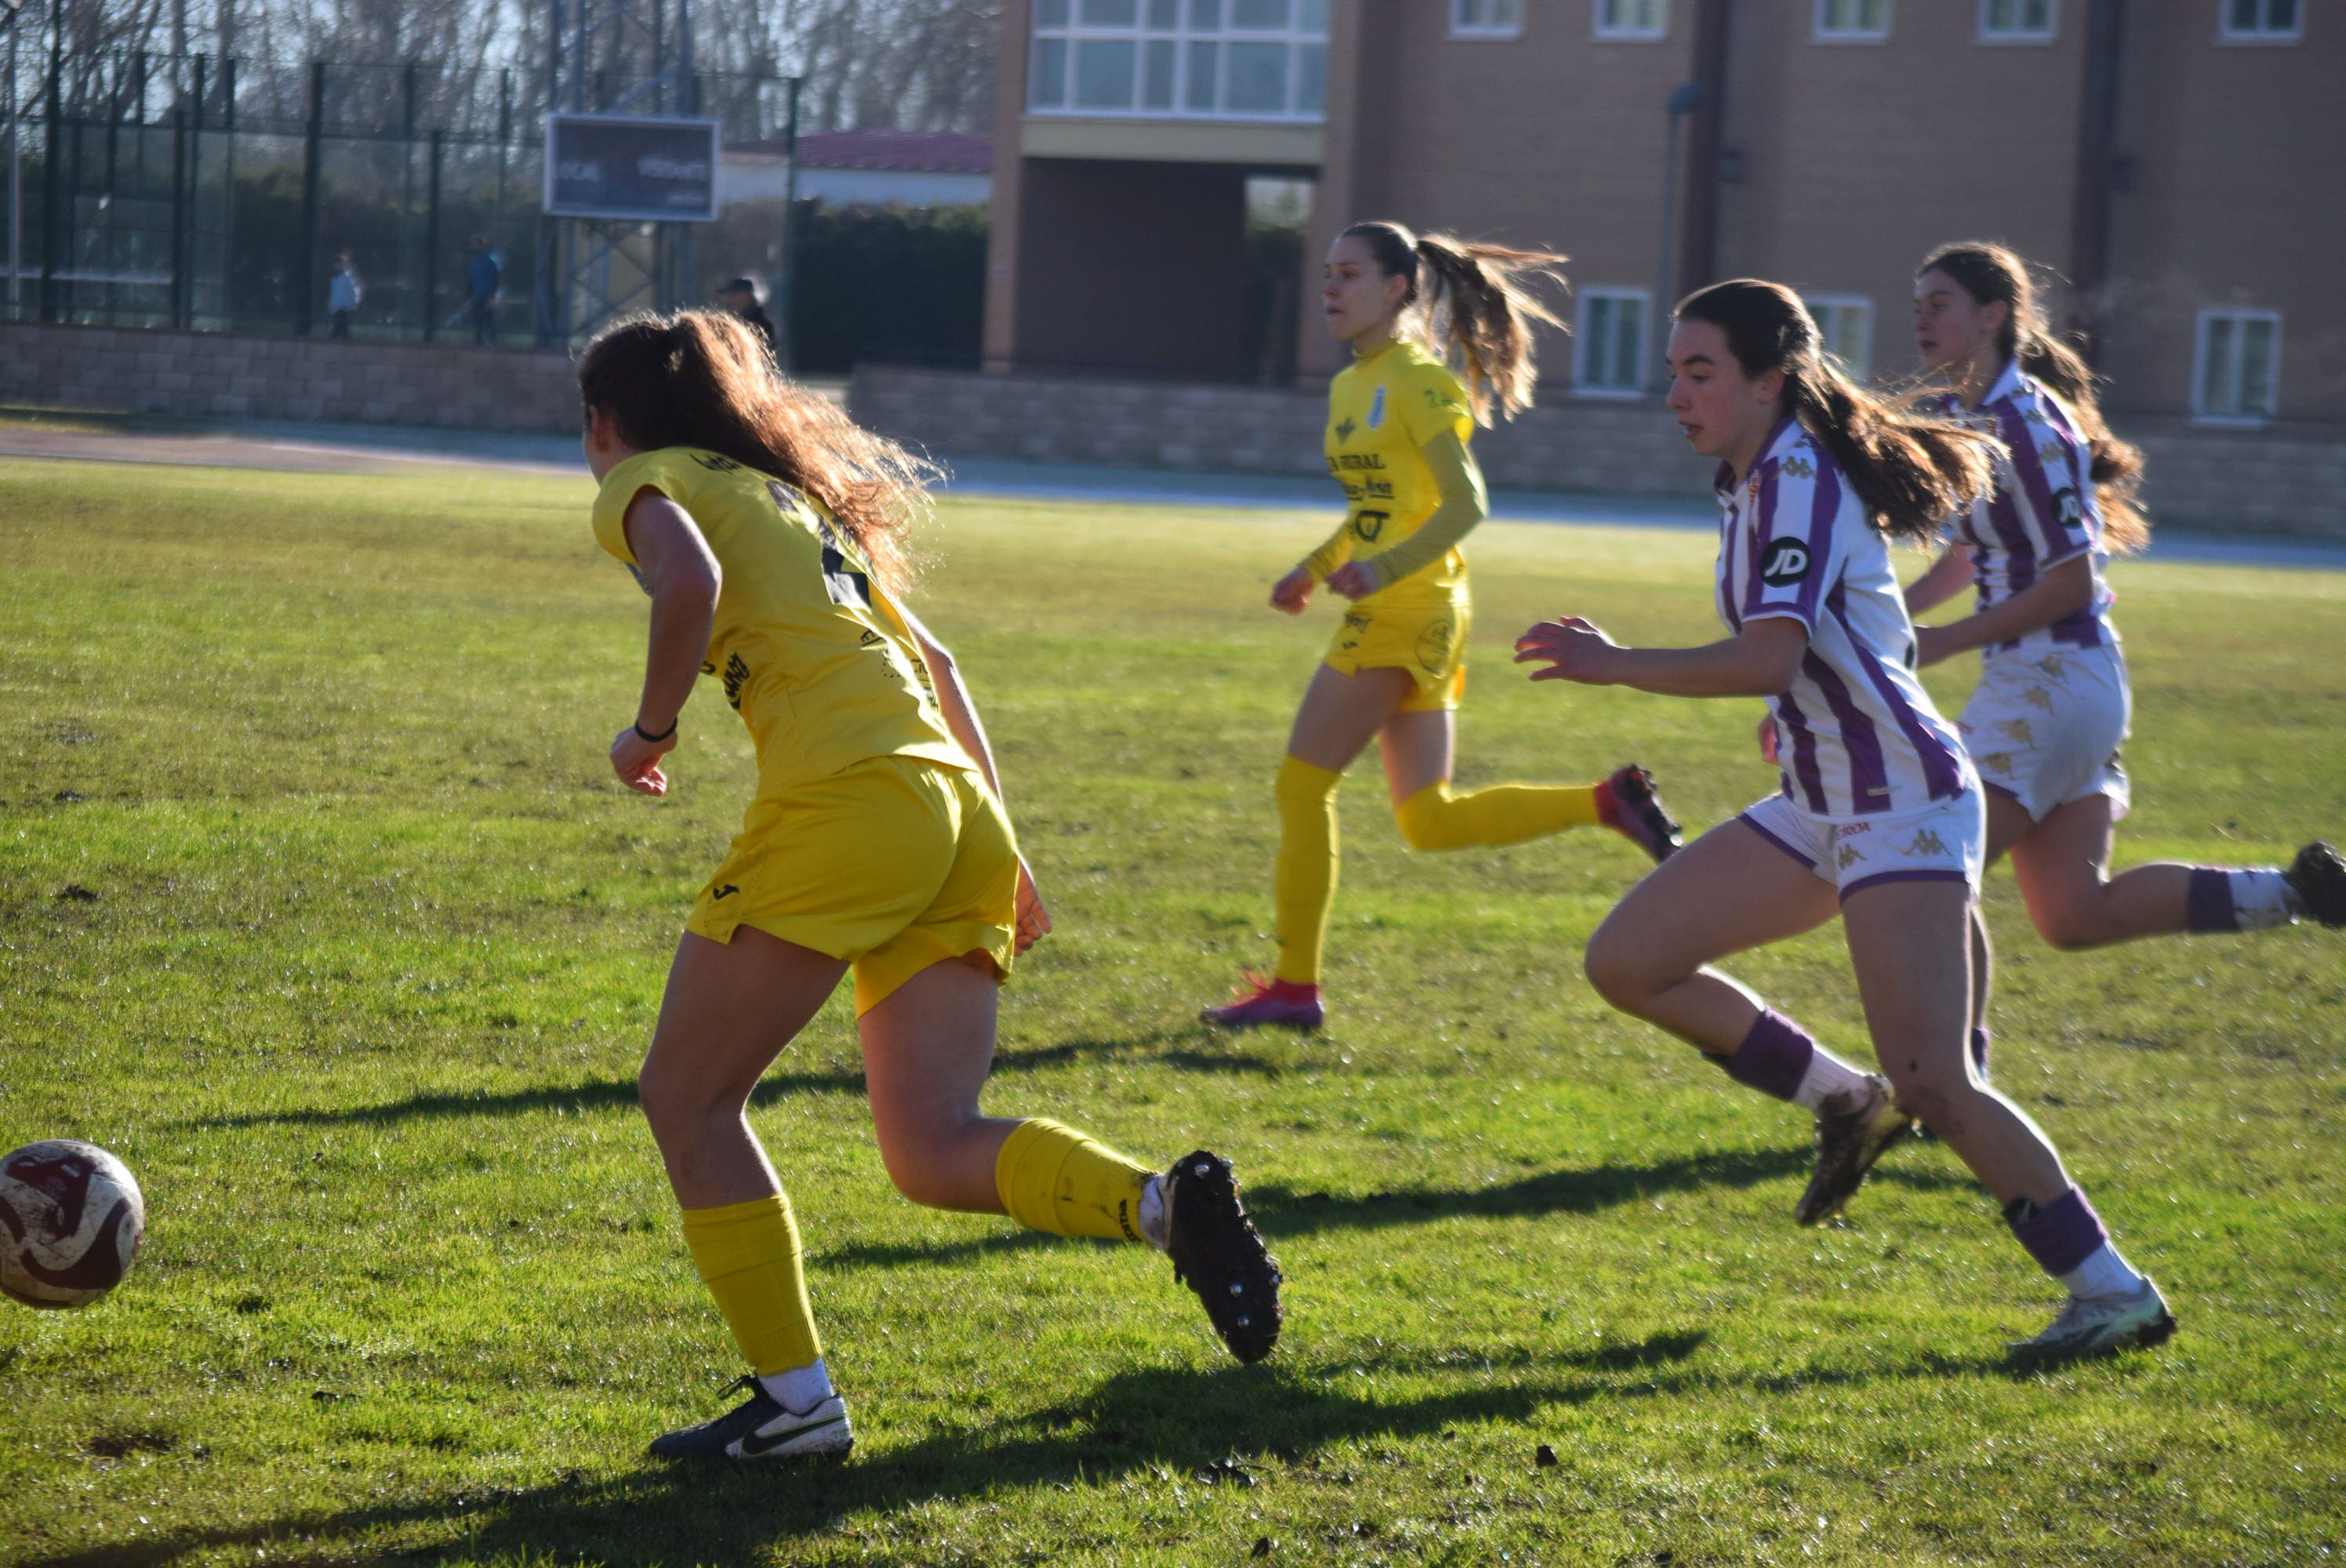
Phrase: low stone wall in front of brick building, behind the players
[{"left": 847, "top": 366, "right": 2346, "bottom": 538}]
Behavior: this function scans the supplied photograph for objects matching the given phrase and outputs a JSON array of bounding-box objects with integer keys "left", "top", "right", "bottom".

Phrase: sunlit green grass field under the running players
[{"left": 0, "top": 445, "right": 2346, "bottom": 1568}]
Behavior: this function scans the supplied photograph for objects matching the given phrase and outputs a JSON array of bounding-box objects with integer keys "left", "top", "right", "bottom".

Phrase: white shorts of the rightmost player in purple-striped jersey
[{"left": 1956, "top": 643, "right": 2135, "bottom": 822}]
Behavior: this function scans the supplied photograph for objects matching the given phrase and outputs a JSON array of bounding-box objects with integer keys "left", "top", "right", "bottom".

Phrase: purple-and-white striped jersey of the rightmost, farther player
[{"left": 1937, "top": 359, "right": 2119, "bottom": 657}]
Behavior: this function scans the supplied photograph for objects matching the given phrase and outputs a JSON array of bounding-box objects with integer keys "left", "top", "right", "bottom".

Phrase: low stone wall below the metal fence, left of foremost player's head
[{"left": 0, "top": 321, "right": 579, "bottom": 430}]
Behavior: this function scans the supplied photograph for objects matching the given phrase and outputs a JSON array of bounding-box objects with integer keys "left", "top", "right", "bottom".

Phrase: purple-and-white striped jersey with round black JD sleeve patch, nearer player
[{"left": 1715, "top": 418, "right": 1977, "bottom": 822}]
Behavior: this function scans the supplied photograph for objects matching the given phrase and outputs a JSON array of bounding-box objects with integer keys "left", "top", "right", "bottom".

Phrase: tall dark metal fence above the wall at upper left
[{"left": 0, "top": 43, "right": 788, "bottom": 343}]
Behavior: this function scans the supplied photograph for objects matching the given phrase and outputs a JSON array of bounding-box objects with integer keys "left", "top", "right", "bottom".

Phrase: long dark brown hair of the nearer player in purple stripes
[{"left": 1670, "top": 277, "right": 1996, "bottom": 543}]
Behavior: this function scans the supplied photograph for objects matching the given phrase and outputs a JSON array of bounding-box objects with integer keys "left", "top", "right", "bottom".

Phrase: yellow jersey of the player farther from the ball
[{"left": 1312, "top": 338, "right": 1473, "bottom": 608}]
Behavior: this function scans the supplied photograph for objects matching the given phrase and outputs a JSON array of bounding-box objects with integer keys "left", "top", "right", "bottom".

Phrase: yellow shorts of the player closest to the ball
[{"left": 685, "top": 756, "right": 1019, "bottom": 1016}]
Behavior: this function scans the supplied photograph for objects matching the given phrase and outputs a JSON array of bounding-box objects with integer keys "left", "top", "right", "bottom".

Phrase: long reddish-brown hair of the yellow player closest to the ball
[{"left": 579, "top": 310, "right": 941, "bottom": 593}]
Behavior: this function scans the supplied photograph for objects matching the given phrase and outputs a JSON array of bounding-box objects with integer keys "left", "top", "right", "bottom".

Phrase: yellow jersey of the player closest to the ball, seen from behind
[{"left": 594, "top": 446, "right": 974, "bottom": 793}]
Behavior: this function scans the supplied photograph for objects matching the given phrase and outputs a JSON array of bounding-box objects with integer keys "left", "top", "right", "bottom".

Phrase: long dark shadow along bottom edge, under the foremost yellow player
[{"left": 19, "top": 1331, "right": 1715, "bottom": 1568}]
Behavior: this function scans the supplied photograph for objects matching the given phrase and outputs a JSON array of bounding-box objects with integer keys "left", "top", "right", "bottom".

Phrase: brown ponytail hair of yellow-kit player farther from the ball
[{"left": 1337, "top": 223, "right": 1567, "bottom": 425}]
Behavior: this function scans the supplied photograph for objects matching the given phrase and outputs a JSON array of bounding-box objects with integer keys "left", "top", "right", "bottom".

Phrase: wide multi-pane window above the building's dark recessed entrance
[{"left": 1027, "top": 0, "right": 1327, "bottom": 125}]
